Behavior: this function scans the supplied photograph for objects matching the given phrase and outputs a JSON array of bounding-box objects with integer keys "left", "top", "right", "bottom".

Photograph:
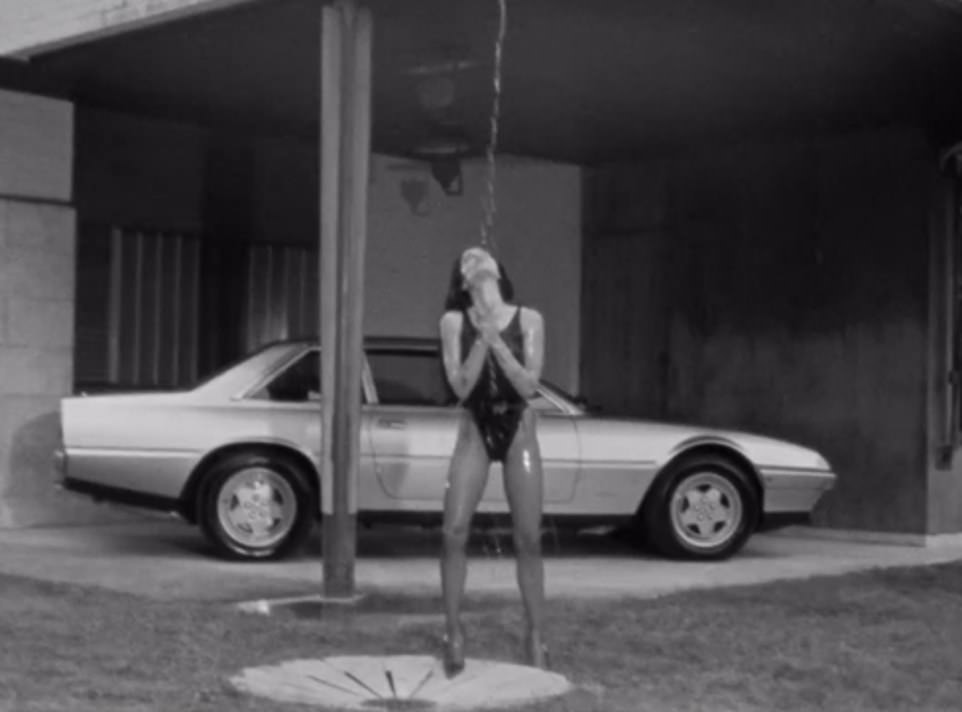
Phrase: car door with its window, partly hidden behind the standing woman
[{"left": 368, "top": 348, "right": 580, "bottom": 511}]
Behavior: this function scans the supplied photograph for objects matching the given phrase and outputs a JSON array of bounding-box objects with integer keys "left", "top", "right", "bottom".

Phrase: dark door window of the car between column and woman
[{"left": 367, "top": 350, "right": 457, "bottom": 407}]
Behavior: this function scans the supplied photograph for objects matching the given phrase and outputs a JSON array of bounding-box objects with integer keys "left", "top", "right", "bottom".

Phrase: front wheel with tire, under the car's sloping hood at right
[{"left": 639, "top": 455, "right": 760, "bottom": 561}]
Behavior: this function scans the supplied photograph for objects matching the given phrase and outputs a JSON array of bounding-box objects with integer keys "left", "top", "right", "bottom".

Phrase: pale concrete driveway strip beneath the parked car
[{"left": 0, "top": 518, "right": 962, "bottom": 602}]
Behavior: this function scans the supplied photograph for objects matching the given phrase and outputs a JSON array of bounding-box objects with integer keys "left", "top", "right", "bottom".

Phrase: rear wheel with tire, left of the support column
[{"left": 197, "top": 453, "right": 314, "bottom": 560}]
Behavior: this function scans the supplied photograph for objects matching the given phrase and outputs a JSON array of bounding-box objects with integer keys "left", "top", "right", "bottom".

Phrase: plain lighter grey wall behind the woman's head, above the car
[{"left": 365, "top": 156, "right": 581, "bottom": 391}]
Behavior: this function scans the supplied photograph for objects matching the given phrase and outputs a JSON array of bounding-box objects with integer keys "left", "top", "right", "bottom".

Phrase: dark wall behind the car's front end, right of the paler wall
[{"left": 584, "top": 130, "right": 935, "bottom": 533}]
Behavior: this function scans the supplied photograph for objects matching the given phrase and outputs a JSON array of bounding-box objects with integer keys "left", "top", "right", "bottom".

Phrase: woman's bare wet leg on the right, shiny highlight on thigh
[{"left": 504, "top": 410, "right": 545, "bottom": 667}]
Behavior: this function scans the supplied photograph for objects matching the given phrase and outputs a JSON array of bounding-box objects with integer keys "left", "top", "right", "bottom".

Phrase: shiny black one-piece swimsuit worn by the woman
[{"left": 461, "top": 307, "right": 528, "bottom": 462}]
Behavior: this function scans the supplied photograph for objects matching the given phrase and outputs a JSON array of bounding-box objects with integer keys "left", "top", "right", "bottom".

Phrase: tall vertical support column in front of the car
[{"left": 319, "top": 0, "right": 372, "bottom": 599}]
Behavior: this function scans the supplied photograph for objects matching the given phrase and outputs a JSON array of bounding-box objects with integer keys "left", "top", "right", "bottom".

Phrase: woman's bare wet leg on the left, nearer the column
[{"left": 441, "top": 415, "right": 491, "bottom": 674}]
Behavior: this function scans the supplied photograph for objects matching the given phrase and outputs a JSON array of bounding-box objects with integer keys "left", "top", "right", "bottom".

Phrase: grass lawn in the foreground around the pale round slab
[{"left": 0, "top": 564, "right": 962, "bottom": 712}]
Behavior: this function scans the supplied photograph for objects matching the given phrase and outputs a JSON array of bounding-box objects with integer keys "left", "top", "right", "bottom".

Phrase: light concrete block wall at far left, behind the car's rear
[{"left": 0, "top": 86, "right": 123, "bottom": 527}]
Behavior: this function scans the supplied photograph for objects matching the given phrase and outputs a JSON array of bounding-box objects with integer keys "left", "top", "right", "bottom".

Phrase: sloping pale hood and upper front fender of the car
[{"left": 578, "top": 416, "right": 831, "bottom": 470}]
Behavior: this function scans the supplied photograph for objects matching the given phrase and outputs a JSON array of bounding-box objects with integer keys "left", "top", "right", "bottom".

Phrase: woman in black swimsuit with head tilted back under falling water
[{"left": 440, "top": 247, "right": 546, "bottom": 677}]
